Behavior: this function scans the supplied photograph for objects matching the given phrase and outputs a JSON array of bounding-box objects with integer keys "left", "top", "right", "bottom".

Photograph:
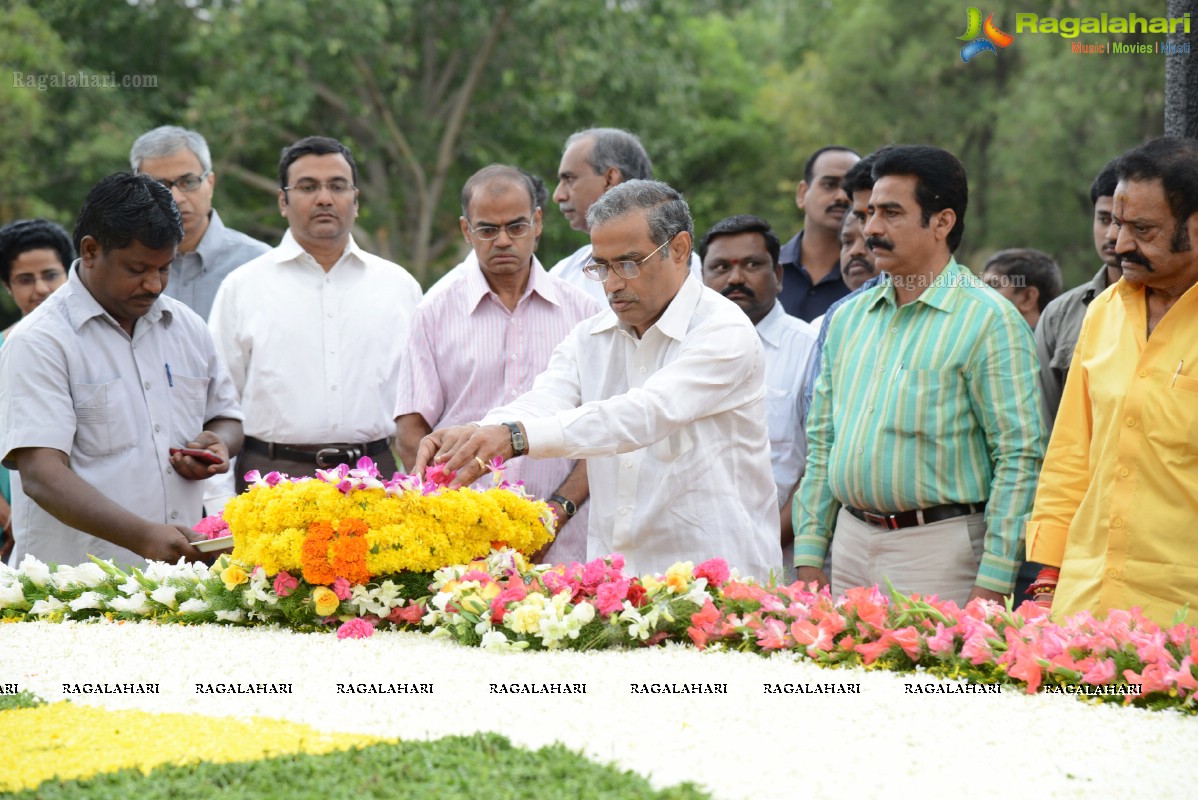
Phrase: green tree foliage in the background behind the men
[{"left": 0, "top": 0, "right": 1164, "bottom": 297}]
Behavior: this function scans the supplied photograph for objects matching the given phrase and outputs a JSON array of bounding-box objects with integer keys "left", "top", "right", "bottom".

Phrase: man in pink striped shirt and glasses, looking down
[{"left": 395, "top": 164, "right": 603, "bottom": 563}]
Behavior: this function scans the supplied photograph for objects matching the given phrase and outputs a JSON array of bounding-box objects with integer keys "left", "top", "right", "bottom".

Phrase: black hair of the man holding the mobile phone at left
[{"left": 73, "top": 172, "right": 183, "bottom": 253}]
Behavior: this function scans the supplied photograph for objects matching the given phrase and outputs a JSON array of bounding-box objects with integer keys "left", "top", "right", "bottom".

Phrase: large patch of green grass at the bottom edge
[{"left": 13, "top": 733, "right": 710, "bottom": 800}]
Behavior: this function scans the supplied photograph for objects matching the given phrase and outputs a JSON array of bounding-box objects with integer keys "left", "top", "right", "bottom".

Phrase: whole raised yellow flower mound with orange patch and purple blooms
[{"left": 222, "top": 459, "right": 553, "bottom": 586}]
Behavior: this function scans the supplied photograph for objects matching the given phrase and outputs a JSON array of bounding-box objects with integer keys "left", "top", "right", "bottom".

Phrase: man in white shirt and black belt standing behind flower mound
[{"left": 208, "top": 137, "right": 420, "bottom": 491}]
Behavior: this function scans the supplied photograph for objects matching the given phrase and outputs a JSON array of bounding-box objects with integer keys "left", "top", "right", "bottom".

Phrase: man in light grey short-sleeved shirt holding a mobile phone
[{"left": 0, "top": 174, "right": 242, "bottom": 565}]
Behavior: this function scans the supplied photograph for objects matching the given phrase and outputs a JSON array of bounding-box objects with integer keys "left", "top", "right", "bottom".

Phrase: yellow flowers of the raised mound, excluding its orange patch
[{"left": 224, "top": 480, "right": 552, "bottom": 576}]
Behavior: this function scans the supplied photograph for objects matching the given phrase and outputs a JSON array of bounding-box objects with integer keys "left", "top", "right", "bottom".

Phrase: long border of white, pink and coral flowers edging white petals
[{"left": 0, "top": 549, "right": 1198, "bottom": 714}]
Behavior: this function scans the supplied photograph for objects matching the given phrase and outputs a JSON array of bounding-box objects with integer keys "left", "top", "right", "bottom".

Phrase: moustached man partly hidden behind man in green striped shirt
[{"left": 698, "top": 214, "right": 816, "bottom": 583}]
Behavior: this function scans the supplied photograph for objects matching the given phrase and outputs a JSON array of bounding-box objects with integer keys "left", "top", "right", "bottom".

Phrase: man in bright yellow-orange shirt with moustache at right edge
[{"left": 1027, "top": 137, "right": 1198, "bottom": 625}]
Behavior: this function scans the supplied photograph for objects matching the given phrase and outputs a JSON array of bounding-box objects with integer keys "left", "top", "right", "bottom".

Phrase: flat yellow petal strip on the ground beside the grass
[{"left": 0, "top": 703, "right": 383, "bottom": 792}]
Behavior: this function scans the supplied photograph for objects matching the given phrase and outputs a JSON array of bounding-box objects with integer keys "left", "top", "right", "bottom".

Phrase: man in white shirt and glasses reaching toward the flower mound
[{"left": 416, "top": 181, "right": 782, "bottom": 580}]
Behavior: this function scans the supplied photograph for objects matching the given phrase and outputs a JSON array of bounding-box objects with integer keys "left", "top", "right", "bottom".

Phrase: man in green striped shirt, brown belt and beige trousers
[{"left": 793, "top": 145, "right": 1046, "bottom": 605}]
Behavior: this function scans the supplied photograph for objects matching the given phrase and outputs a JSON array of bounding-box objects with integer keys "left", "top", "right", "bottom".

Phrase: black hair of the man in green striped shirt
[{"left": 873, "top": 145, "right": 969, "bottom": 253}]
